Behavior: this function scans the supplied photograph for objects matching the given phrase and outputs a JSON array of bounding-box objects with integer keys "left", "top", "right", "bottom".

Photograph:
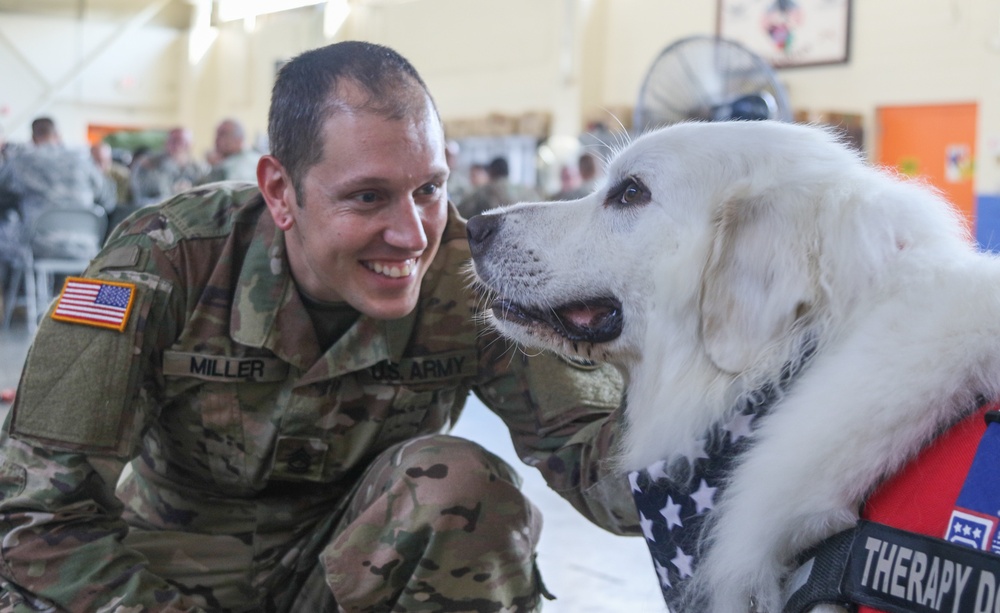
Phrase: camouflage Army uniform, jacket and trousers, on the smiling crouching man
[{"left": 0, "top": 183, "right": 637, "bottom": 612}]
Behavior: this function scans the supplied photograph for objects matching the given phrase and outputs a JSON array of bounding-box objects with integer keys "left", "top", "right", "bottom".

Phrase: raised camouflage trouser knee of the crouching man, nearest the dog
[{"left": 291, "top": 436, "right": 547, "bottom": 613}]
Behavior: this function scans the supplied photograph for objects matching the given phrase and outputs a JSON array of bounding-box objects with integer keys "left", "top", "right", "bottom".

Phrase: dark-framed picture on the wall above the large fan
[{"left": 716, "top": 0, "right": 851, "bottom": 68}]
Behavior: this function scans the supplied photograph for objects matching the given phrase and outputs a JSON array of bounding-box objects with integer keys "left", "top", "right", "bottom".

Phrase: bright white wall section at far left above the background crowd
[{"left": 0, "top": 14, "right": 185, "bottom": 145}]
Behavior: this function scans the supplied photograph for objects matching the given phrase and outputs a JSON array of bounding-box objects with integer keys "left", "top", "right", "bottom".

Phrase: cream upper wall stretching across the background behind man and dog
[{"left": 0, "top": 0, "right": 1000, "bottom": 192}]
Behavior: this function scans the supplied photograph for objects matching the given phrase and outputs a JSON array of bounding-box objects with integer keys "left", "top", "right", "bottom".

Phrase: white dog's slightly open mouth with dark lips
[{"left": 492, "top": 298, "right": 623, "bottom": 343}]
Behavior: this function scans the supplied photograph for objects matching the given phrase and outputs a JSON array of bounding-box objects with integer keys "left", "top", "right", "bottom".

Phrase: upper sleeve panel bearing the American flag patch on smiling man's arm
[{"left": 10, "top": 245, "right": 172, "bottom": 458}]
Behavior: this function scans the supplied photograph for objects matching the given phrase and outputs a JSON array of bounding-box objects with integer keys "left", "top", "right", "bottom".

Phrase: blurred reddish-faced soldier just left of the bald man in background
[{"left": 131, "top": 127, "right": 208, "bottom": 207}]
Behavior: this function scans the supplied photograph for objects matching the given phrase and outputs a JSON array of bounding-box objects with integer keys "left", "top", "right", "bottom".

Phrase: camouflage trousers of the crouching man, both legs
[{"left": 0, "top": 435, "right": 550, "bottom": 613}]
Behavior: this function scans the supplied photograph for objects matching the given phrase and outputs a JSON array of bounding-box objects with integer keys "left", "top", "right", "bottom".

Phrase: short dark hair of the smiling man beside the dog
[{"left": 267, "top": 41, "right": 437, "bottom": 200}]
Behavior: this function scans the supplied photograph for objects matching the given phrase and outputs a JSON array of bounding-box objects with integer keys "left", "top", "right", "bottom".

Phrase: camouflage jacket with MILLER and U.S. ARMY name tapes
[{"left": 0, "top": 184, "right": 637, "bottom": 611}]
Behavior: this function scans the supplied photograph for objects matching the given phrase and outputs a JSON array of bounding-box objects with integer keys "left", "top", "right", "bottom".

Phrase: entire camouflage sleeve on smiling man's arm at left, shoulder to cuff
[{"left": 0, "top": 220, "right": 197, "bottom": 612}]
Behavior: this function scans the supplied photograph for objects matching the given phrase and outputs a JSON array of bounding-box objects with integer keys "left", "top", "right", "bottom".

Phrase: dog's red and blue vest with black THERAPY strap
[{"left": 784, "top": 404, "right": 1000, "bottom": 613}]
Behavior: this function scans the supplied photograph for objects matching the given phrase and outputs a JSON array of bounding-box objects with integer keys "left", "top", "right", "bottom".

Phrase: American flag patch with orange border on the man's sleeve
[{"left": 52, "top": 277, "right": 135, "bottom": 332}]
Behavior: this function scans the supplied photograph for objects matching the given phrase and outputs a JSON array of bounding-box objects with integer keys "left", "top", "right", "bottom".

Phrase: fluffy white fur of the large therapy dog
[{"left": 470, "top": 122, "right": 1000, "bottom": 613}]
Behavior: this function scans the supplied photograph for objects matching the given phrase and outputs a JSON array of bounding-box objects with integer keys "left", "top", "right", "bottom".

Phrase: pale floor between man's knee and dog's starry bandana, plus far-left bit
[{"left": 0, "top": 315, "right": 666, "bottom": 613}]
